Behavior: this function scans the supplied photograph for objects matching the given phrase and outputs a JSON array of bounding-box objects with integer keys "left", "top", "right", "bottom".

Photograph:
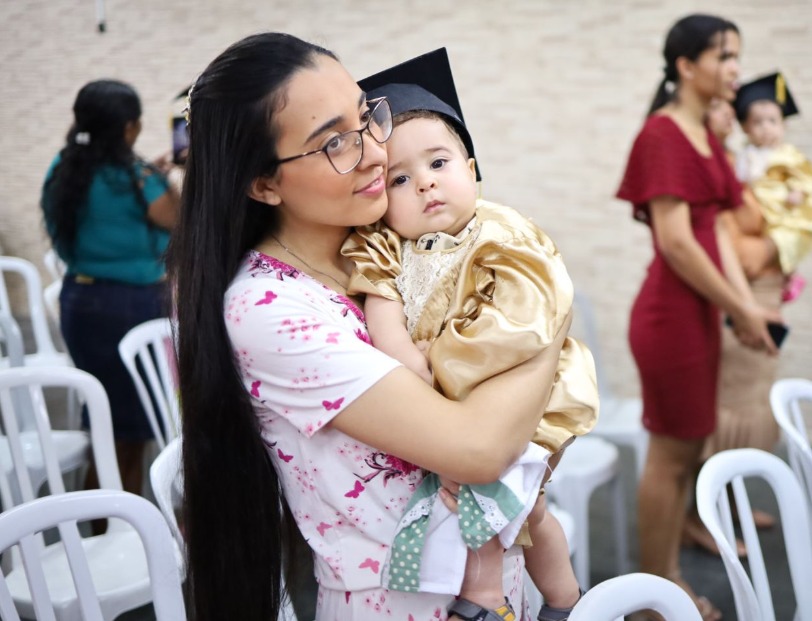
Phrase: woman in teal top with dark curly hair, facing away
[{"left": 42, "top": 80, "right": 178, "bottom": 493}]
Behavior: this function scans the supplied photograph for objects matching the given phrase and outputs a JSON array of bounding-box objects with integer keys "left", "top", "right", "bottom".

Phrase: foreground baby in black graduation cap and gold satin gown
[{"left": 342, "top": 49, "right": 598, "bottom": 621}]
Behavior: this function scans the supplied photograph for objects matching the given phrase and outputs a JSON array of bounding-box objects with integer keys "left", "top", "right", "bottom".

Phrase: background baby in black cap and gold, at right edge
[{"left": 734, "top": 73, "right": 812, "bottom": 276}]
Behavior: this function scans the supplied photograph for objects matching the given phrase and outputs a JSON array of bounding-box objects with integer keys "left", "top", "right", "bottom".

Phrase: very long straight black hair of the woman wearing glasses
[{"left": 168, "top": 33, "right": 335, "bottom": 621}]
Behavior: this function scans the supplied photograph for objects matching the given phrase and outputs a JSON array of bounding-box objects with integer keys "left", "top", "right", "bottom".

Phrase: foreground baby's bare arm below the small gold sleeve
[{"left": 364, "top": 295, "right": 431, "bottom": 385}]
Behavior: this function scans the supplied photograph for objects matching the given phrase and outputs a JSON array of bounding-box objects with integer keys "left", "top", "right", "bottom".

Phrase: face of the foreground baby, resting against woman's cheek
[{"left": 383, "top": 118, "right": 477, "bottom": 240}]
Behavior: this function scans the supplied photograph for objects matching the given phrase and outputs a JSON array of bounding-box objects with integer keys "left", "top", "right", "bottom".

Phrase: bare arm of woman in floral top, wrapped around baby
[{"left": 331, "top": 317, "right": 571, "bottom": 483}]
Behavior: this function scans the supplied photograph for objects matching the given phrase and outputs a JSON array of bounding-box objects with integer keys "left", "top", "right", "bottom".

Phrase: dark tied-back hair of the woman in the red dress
[{"left": 648, "top": 13, "right": 739, "bottom": 115}]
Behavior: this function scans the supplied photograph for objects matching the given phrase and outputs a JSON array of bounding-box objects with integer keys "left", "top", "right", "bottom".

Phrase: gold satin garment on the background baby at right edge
[{"left": 752, "top": 144, "right": 812, "bottom": 274}]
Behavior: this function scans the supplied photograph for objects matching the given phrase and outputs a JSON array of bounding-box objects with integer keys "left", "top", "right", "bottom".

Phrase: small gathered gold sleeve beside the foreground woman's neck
[{"left": 341, "top": 222, "right": 403, "bottom": 302}]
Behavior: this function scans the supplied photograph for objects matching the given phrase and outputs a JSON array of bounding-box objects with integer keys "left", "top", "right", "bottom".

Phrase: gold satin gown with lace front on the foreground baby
[{"left": 342, "top": 200, "right": 598, "bottom": 453}]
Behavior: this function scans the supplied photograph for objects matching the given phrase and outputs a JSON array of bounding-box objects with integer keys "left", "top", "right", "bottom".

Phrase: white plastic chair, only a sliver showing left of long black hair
[{"left": 149, "top": 436, "right": 297, "bottom": 621}]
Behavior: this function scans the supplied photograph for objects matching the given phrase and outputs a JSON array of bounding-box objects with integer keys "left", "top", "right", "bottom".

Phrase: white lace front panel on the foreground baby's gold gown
[{"left": 395, "top": 229, "right": 478, "bottom": 335}]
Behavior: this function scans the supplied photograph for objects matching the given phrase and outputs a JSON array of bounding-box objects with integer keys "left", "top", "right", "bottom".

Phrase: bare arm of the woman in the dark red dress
[{"left": 651, "top": 196, "right": 776, "bottom": 354}]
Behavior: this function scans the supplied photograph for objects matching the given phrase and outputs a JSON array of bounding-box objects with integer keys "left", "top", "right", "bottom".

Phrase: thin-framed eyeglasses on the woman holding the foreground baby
[{"left": 276, "top": 97, "right": 392, "bottom": 175}]
